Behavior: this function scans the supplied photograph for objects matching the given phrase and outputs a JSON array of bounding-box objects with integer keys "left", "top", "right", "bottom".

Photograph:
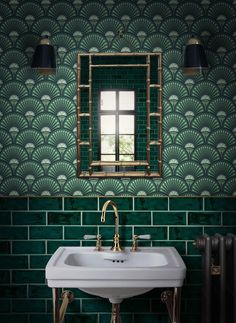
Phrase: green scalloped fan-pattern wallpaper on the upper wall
[{"left": 0, "top": 0, "right": 236, "bottom": 196}]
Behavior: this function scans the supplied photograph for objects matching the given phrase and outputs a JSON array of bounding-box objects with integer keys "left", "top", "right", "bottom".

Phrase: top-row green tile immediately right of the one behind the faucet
[{"left": 134, "top": 197, "right": 168, "bottom": 211}]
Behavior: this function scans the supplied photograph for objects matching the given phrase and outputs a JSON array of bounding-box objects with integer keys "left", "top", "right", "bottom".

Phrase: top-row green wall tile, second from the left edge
[{"left": 29, "top": 197, "right": 62, "bottom": 211}]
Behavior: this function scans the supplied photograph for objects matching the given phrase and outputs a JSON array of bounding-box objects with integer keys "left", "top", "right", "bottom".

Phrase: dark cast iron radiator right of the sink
[{"left": 195, "top": 233, "right": 236, "bottom": 323}]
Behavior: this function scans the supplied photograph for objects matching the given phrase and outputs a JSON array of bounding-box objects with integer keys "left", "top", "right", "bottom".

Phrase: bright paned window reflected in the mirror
[{"left": 99, "top": 90, "right": 135, "bottom": 171}]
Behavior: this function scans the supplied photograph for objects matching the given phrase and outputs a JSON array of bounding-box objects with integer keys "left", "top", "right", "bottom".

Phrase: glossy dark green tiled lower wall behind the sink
[{"left": 0, "top": 196, "right": 236, "bottom": 323}]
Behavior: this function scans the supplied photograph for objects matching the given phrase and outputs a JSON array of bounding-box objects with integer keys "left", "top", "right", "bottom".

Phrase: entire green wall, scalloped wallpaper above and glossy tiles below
[{"left": 0, "top": 0, "right": 236, "bottom": 323}]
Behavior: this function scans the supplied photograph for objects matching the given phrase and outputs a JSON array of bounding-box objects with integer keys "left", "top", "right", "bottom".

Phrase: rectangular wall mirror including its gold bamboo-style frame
[{"left": 77, "top": 53, "right": 162, "bottom": 177}]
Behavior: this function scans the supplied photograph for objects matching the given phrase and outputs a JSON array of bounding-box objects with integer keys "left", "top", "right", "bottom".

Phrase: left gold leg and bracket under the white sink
[{"left": 53, "top": 288, "right": 74, "bottom": 323}]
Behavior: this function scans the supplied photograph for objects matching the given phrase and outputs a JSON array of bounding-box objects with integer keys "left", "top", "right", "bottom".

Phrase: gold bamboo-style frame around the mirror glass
[{"left": 77, "top": 52, "right": 162, "bottom": 178}]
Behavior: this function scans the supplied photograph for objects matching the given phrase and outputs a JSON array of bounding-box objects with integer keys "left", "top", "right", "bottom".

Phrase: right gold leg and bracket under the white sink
[{"left": 161, "top": 287, "right": 181, "bottom": 323}]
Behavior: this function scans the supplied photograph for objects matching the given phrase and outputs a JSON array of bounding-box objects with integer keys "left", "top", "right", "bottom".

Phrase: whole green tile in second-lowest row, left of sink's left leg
[{"left": 12, "top": 299, "right": 45, "bottom": 313}]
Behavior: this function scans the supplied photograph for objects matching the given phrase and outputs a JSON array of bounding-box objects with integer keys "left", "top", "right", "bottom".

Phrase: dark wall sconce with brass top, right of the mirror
[{"left": 183, "top": 37, "right": 208, "bottom": 75}]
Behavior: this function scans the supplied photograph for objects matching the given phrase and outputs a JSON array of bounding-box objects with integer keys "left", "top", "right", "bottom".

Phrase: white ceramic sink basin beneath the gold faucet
[{"left": 46, "top": 247, "right": 186, "bottom": 303}]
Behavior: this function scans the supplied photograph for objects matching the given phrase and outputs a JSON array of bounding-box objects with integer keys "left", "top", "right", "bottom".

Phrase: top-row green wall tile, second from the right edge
[{"left": 170, "top": 197, "right": 203, "bottom": 210}]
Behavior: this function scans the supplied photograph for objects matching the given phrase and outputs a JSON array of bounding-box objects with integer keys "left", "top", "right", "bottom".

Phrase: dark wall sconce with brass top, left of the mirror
[{"left": 31, "top": 36, "right": 56, "bottom": 75}]
